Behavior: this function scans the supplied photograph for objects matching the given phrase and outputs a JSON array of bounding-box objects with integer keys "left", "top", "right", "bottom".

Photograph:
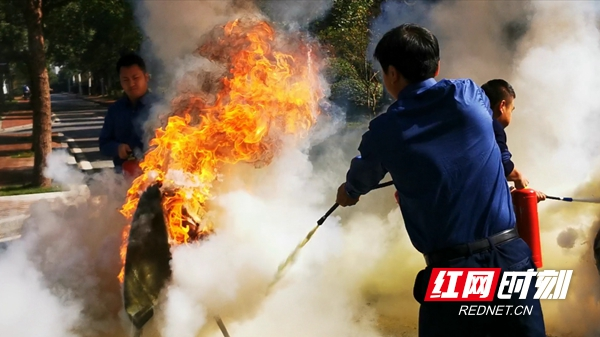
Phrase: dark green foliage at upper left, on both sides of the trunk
[{"left": 0, "top": 0, "right": 143, "bottom": 96}]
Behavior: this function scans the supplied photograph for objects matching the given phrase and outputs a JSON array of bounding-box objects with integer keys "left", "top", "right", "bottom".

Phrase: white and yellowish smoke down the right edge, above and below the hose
[{"left": 507, "top": 2, "right": 600, "bottom": 335}]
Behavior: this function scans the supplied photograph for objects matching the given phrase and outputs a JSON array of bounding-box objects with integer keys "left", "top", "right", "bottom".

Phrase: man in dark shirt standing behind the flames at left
[{"left": 99, "top": 54, "right": 157, "bottom": 173}]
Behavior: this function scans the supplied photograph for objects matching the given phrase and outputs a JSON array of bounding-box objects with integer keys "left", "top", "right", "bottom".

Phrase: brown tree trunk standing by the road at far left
[{"left": 24, "top": 0, "right": 52, "bottom": 187}]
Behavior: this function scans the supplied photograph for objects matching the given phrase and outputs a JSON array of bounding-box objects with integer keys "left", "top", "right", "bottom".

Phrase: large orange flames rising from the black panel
[{"left": 119, "top": 20, "right": 323, "bottom": 281}]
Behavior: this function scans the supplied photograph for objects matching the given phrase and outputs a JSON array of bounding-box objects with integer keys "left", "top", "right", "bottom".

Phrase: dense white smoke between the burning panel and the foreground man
[{"left": 150, "top": 140, "right": 418, "bottom": 336}]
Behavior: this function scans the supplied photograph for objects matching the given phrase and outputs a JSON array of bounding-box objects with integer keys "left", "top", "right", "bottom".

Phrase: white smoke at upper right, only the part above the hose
[{"left": 508, "top": 2, "right": 600, "bottom": 193}]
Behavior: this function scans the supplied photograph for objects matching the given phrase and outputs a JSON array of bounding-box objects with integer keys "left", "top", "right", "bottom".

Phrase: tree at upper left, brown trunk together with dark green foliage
[{"left": 0, "top": 0, "right": 142, "bottom": 186}]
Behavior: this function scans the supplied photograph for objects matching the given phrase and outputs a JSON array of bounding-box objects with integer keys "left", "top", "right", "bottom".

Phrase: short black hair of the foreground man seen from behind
[{"left": 373, "top": 23, "right": 440, "bottom": 83}]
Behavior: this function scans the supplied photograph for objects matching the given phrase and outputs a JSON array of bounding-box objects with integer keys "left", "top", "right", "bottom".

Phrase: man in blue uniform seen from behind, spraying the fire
[{"left": 337, "top": 24, "right": 545, "bottom": 337}]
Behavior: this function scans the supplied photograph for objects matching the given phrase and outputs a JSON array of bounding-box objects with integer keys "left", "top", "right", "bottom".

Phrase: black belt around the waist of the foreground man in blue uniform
[{"left": 425, "top": 228, "right": 519, "bottom": 266}]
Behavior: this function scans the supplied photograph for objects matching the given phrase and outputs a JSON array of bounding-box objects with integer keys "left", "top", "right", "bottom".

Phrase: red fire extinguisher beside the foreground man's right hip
[{"left": 512, "top": 188, "right": 542, "bottom": 268}]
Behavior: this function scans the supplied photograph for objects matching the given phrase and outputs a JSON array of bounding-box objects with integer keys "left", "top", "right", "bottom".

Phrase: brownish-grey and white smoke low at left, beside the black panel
[{"left": 0, "top": 152, "right": 134, "bottom": 337}]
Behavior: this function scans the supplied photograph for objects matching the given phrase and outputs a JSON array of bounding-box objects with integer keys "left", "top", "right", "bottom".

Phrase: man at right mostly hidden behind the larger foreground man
[{"left": 481, "top": 79, "right": 546, "bottom": 201}]
